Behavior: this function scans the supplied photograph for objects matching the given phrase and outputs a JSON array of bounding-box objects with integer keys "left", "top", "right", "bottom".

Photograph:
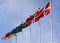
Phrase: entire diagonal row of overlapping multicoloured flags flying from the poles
[{"left": 2, "top": 2, "right": 50, "bottom": 39}]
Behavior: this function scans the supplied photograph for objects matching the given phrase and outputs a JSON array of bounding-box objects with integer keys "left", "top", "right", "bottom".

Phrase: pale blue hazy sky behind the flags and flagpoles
[{"left": 0, "top": 0, "right": 60, "bottom": 43}]
